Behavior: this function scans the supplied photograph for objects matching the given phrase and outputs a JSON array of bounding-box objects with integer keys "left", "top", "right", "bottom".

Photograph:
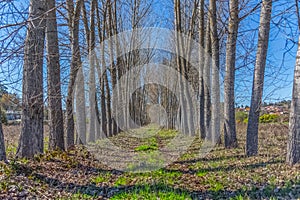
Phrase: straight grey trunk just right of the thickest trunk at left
[{"left": 46, "top": 0, "right": 65, "bottom": 150}]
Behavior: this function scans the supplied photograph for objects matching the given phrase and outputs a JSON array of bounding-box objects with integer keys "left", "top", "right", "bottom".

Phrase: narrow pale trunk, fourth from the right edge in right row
[{"left": 209, "top": 0, "right": 220, "bottom": 144}]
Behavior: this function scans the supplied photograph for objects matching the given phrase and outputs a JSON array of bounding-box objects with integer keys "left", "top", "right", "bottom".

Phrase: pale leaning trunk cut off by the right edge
[{"left": 286, "top": 0, "right": 300, "bottom": 165}]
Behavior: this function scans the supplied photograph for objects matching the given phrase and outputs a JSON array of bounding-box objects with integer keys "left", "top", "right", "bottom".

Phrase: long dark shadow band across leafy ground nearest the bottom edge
[{"left": 32, "top": 171, "right": 300, "bottom": 199}]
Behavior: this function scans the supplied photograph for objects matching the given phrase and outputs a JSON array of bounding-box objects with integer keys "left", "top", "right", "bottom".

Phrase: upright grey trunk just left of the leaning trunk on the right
[{"left": 224, "top": 0, "right": 239, "bottom": 148}]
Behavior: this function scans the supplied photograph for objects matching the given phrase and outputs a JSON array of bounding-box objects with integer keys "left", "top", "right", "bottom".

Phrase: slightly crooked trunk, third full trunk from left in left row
[{"left": 66, "top": 0, "right": 83, "bottom": 148}]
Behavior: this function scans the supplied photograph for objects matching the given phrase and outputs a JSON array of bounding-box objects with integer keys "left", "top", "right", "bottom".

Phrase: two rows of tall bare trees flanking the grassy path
[{"left": 0, "top": 0, "right": 300, "bottom": 164}]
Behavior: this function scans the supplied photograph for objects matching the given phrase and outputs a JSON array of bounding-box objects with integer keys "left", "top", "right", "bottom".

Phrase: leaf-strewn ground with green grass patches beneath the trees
[{"left": 0, "top": 124, "right": 300, "bottom": 199}]
